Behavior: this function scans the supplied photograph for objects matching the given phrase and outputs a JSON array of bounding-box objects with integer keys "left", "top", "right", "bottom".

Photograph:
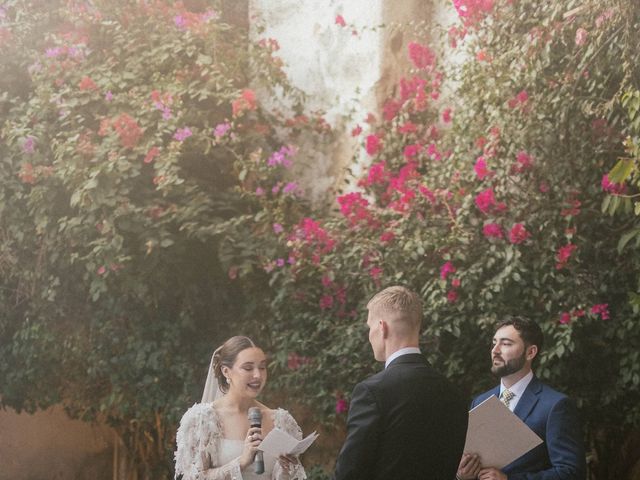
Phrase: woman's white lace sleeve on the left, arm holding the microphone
[{"left": 175, "top": 403, "right": 242, "bottom": 480}]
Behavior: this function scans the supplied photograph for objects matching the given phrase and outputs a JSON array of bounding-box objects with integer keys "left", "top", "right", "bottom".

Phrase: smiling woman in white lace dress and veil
[{"left": 175, "top": 336, "right": 307, "bottom": 480}]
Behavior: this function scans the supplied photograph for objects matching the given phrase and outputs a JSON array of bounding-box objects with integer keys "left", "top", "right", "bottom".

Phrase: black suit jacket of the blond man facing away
[{"left": 334, "top": 354, "right": 468, "bottom": 480}]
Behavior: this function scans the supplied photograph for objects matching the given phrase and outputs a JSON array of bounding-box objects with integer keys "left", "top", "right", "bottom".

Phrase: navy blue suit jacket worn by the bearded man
[{"left": 471, "top": 376, "right": 586, "bottom": 480}]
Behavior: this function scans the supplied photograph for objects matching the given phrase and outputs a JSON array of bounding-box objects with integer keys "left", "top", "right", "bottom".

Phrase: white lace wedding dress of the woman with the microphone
[{"left": 175, "top": 403, "right": 307, "bottom": 480}]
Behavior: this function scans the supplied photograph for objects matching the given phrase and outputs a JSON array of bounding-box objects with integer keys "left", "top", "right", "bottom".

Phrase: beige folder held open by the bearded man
[{"left": 464, "top": 395, "right": 542, "bottom": 469}]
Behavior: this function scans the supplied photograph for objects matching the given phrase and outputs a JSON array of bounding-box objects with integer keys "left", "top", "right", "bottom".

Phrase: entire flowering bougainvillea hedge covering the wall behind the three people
[{"left": 0, "top": 0, "right": 640, "bottom": 479}]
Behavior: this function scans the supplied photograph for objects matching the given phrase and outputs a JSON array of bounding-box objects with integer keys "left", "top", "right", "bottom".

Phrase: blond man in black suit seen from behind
[{"left": 334, "top": 287, "right": 468, "bottom": 480}]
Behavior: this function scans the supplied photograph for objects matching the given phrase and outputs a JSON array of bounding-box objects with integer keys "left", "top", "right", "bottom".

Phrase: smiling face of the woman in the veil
[{"left": 222, "top": 347, "right": 267, "bottom": 398}]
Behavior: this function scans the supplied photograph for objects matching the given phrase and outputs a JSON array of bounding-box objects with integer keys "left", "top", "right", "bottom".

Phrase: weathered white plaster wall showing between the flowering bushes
[{"left": 249, "top": 0, "right": 434, "bottom": 202}]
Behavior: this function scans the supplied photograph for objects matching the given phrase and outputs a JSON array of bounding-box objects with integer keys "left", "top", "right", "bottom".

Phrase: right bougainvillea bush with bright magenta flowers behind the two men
[{"left": 221, "top": 0, "right": 640, "bottom": 478}]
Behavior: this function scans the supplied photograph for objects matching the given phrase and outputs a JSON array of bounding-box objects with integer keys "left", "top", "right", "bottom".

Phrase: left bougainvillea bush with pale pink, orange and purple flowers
[{"left": 0, "top": 1, "right": 325, "bottom": 478}]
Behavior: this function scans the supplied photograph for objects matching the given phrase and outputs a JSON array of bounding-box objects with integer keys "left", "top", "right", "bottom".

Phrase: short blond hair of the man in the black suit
[{"left": 367, "top": 285, "right": 422, "bottom": 333}]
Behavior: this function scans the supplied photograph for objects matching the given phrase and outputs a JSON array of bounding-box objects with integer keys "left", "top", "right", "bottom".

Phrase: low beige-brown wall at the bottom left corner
[{"left": 0, "top": 407, "right": 114, "bottom": 480}]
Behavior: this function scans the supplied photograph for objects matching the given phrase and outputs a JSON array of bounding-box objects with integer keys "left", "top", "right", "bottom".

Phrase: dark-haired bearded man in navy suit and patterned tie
[{"left": 456, "top": 316, "right": 586, "bottom": 480}]
